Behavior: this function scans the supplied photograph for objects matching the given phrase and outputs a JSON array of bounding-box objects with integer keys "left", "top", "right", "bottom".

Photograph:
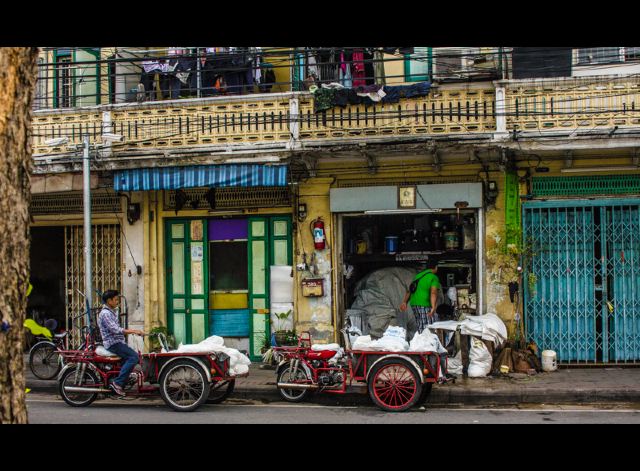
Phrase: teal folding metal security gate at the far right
[{"left": 523, "top": 199, "right": 640, "bottom": 364}]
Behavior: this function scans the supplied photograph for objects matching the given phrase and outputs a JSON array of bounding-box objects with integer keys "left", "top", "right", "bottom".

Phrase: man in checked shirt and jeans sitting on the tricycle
[{"left": 98, "top": 289, "right": 144, "bottom": 396}]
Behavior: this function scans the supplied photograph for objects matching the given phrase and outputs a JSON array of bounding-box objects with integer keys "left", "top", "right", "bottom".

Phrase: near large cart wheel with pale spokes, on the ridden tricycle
[{"left": 160, "top": 360, "right": 210, "bottom": 412}]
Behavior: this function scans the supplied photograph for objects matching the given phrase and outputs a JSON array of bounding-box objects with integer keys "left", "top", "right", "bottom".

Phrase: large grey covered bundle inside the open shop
[{"left": 351, "top": 267, "right": 418, "bottom": 340}]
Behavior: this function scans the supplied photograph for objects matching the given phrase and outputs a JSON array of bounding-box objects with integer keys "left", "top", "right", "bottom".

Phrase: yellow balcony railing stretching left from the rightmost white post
[{"left": 33, "top": 87, "right": 496, "bottom": 155}]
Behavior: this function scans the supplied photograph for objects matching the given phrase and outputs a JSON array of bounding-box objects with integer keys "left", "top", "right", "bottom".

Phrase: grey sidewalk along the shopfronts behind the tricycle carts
[{"left": 25, "top": 358, "right": 640, "bottom": 405}]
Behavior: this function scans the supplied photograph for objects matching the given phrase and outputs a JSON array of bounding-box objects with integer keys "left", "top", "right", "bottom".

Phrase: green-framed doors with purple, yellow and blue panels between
[{"left": 166, "top": 216, "right": 293, "bottom": 360}]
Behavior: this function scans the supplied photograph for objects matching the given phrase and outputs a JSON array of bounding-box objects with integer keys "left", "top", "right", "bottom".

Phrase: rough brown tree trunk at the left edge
[{"left": 0, "top": 47, "right": 38, "bottom": 424}]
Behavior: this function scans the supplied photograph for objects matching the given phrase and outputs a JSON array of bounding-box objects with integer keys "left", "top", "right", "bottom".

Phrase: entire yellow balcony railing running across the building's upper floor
[{"left": 33, "top": 71, "right": 640, "bottom": 155}]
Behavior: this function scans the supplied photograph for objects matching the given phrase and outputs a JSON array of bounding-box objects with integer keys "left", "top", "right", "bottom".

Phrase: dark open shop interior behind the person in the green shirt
[{"left": 338, "top": 209, "right": 480, "bottom": 340}]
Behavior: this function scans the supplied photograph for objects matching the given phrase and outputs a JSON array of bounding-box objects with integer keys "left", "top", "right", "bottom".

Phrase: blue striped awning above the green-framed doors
[{"left": 113, "top": 164, "right": 288, "bottom": 191}]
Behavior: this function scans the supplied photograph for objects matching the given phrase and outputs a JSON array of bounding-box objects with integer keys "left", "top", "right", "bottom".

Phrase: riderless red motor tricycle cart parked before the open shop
[{"left": 274, "top": 329, "right": 441, "bottom": 412}]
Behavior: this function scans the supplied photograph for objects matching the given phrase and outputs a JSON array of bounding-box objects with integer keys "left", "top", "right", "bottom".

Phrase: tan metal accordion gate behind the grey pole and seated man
[{"left": 64, "top": 224, "right": 122, "bottom": 345}]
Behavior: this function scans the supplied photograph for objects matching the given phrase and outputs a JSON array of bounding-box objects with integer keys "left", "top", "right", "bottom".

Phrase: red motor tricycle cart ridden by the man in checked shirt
[{"left": 58, "top": 334, "right": 248, "bottom": 412}]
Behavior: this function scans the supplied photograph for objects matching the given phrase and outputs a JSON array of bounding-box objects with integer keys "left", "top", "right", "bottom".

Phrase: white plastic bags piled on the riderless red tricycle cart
[{"left": 353, "top": 326, "right": 447, "bottom": 353}]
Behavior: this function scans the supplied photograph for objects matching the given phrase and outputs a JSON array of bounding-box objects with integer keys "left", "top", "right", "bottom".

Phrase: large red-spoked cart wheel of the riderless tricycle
[{"left": 368, "top": 358, "right": 422, "bottom": 412}]
